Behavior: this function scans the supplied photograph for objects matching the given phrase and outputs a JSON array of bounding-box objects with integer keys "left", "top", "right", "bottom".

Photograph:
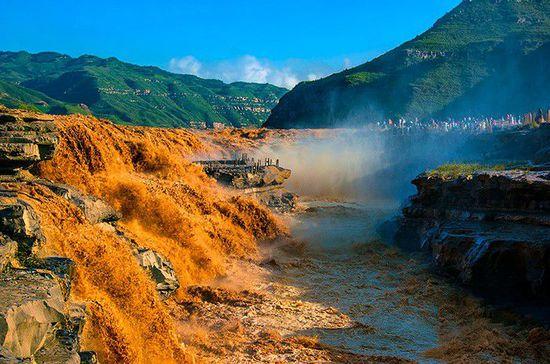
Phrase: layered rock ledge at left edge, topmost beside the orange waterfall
[{"left": 0, "top": 107, "right": 59, "bottom": 174}]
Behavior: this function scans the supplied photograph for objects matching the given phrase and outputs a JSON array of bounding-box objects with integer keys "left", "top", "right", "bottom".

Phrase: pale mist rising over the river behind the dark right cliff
[{"left": 255, "top": 129, "right": 488, "bottom": 204}]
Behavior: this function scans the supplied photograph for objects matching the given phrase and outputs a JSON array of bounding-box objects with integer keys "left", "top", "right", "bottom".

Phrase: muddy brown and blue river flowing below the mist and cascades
[{"left": 268, "top": 200, "right": 541, "bottom": 362}]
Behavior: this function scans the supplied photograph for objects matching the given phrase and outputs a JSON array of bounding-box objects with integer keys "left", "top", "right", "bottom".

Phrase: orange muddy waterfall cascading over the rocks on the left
[{"left": 17, "top": 115, "right": 282, "bottom": 363}]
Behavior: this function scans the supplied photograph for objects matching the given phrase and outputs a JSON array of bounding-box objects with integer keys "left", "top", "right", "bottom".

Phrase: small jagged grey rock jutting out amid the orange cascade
[{"left": 136, "top": 248, "right": 180, "bottom": 296}]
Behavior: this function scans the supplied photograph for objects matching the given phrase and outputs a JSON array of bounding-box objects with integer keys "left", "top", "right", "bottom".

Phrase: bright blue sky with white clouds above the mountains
[{"left": 0, "top": 0, "right": 460, "bottom": 87}]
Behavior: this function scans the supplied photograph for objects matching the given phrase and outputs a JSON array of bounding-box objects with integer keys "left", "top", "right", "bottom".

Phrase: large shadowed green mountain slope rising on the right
[{"left": 265, "top": 0, "right": 550, "bottom": 128}]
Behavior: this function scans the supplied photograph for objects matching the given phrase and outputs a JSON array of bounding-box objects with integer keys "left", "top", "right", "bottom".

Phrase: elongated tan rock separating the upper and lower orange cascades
[{"left": 36, "top": 180, "right": 120, "bottom": 224}]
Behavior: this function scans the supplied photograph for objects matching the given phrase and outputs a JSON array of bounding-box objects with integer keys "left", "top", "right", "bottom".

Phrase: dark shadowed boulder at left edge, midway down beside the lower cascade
[{"left": 0, "top": 198, "right": 44, "bottom": 257}]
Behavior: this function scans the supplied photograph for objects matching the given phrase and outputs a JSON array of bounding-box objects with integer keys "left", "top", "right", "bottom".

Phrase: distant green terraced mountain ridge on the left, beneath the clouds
[{"left": 0, "top": 52, "right": 287, "bottom": 127}]
